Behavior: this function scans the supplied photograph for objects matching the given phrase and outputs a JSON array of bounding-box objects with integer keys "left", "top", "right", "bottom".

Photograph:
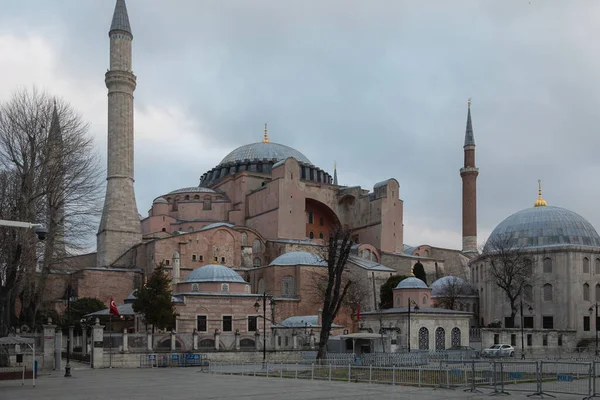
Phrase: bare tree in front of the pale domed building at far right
[{"left": 479, "top": 235, "right": 533, "bottom": 327}]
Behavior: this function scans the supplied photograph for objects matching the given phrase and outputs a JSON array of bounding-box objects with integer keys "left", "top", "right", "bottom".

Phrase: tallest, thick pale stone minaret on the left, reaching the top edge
[{"left": 96, "top": 0, "right": 142, "bottom": 267}]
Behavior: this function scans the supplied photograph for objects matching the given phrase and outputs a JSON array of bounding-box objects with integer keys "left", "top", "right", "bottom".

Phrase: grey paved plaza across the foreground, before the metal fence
[{"left": 0, "top": 368, "right": 582, "bottom": 400}]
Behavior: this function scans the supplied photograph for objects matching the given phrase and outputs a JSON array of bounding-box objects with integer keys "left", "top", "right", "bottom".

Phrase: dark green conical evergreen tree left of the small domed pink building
[{"left": 133, "top": 263, "right": 177, "bottom": 331}]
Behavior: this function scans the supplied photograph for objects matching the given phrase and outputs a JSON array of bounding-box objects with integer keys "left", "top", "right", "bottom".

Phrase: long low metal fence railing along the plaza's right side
[{"left": 203, "top": 360, "right": 600, "bottom": 398}]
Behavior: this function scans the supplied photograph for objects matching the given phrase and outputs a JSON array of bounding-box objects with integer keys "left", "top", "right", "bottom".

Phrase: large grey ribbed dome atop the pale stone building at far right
[{"left": 486, "top": 206, "right": 600, "bottom": 250}]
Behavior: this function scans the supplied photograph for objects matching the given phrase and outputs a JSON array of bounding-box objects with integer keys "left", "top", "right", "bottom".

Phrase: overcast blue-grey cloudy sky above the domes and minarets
[{"left": 0, "top": 0, "right": 600, "bottom": 248}]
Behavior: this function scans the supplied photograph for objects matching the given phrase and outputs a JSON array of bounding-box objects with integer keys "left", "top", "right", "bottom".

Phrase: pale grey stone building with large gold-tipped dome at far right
[{"left": 471, "top": 187, "right": 600, "bottom": 351}]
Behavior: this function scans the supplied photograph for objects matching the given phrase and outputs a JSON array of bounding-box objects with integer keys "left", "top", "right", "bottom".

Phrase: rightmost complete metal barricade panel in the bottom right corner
[{"left": 538, "top": 361, "right": 594, "bottom": 397}]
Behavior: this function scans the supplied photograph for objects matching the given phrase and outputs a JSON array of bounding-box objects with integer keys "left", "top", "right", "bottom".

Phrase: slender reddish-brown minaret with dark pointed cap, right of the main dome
[{"left": 460, "top": 99, "right": 479, "bottom": 252}]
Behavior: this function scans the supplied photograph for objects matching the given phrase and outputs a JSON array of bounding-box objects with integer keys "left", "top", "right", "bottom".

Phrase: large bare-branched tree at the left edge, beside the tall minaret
[{"left": 0, "top": 89, "right": 102, "bottom": 334}]
